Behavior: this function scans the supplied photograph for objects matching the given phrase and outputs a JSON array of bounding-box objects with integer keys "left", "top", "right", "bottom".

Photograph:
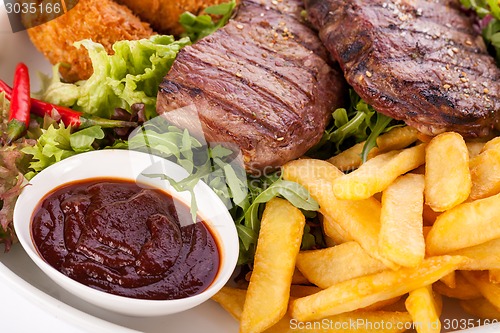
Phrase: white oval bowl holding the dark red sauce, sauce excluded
[{"left": 14, "top": 150, "right": 238, "bottom": 316}]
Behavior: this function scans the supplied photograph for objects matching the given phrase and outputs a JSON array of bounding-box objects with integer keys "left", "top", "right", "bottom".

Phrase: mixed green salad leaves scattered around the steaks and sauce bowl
[{"left": 0, "top": 0, "right": 500, "bottom": 264}]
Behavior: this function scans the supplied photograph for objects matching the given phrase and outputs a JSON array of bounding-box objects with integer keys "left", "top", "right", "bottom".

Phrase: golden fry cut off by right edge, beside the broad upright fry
[{"left": 469, "top": 147, "right": 500, "bottom": 200}]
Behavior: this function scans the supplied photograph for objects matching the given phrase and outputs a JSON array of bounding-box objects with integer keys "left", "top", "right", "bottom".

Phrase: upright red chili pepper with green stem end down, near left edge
[{"left": 7, "top": 63, "right": 31, "bottom": 144}]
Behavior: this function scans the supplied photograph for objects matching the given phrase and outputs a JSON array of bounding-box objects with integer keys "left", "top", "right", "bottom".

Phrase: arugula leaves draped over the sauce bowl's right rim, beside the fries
[{"left": 128, "top": 117, "right": 319, "bottom": 264}]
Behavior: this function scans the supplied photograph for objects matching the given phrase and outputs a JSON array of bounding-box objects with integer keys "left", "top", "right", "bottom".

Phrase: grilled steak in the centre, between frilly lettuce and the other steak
[{"left": 157, "top": 0, "right": 345, "bottom": 174}]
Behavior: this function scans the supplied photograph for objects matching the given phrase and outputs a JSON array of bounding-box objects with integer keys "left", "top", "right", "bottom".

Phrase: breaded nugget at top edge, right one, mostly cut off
[{"left": 115, "top": 0, "right": 229, "bottom": 35}]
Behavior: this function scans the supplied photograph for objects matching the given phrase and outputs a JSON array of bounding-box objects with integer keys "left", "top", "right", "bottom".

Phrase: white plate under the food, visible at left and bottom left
[{"left": 0, "top": 0, "right": 500, "bottom": 333}]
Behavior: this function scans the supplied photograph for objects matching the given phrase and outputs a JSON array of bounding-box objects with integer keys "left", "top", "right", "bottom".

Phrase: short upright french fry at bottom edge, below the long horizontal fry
[{"left": 405, "top": 285, "right": 441, "bottom": 333}]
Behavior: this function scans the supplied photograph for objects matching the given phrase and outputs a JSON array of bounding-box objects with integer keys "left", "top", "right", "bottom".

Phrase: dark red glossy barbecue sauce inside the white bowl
[{"left": 32, "top": 179, "right": 220, "bottom": 300}]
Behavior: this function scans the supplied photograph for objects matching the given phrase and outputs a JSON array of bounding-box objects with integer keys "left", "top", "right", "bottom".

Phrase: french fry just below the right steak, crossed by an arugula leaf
[{"left": 328, "top": 126, "right": 418, "bottom": 171}]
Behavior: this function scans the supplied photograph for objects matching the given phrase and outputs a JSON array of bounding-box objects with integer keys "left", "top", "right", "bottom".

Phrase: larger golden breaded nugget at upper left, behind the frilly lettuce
[{"left": 25, "top": 0, "right": 153, "bottom": 82}]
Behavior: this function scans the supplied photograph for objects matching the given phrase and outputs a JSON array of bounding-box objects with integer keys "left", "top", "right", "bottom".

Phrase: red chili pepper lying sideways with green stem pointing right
[{"left": 0, "top": 80, "right": 137, "bottom": 128}]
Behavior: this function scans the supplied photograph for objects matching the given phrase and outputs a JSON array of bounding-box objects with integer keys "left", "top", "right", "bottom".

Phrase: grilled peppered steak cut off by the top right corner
[{"left": 305, "top": 0, "right": 500, "bottom": 136}]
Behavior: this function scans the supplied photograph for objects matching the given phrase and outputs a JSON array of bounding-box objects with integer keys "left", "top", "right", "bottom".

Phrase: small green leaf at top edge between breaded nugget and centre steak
[{"left": 179, "top": 0, "right": 236, "bottom": 43}]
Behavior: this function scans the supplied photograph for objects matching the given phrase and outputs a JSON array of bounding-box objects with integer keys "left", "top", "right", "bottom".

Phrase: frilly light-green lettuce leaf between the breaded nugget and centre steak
[{"left": 36, "top": 35, "right": 190, "bottom": 118}]
